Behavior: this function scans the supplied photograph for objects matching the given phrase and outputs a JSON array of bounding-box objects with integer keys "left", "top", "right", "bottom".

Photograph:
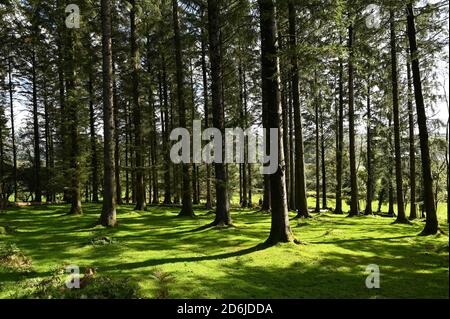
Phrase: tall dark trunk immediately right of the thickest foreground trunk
[{"left": 289, "top": 0, "right": 309, "bottom": 217}]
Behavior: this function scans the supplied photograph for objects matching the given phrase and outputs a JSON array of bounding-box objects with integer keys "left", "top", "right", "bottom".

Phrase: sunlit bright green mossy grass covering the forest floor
[{"left": 0, "top": 204, "right": 449, "bottom": 298}]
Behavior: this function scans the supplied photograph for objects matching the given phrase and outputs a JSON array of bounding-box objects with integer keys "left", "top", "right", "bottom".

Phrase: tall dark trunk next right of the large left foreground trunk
[{"left": 130, "top": 0, "right": 145, "bottom": 210}]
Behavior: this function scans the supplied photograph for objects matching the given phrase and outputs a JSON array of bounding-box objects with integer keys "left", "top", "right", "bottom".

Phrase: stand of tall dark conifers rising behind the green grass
[{"left": 0, "top": 0, "right": 450, "bottom": 243}]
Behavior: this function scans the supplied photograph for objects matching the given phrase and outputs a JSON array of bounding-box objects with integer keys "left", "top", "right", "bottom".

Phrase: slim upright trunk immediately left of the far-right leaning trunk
[{"left": 406, "top": 61, "right": 417, "bottom": 219}]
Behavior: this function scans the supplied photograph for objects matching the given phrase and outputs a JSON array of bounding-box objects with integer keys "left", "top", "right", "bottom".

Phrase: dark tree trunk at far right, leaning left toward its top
[{"left": 407, "top": 2, "right": 439, "bottom": 235}]
